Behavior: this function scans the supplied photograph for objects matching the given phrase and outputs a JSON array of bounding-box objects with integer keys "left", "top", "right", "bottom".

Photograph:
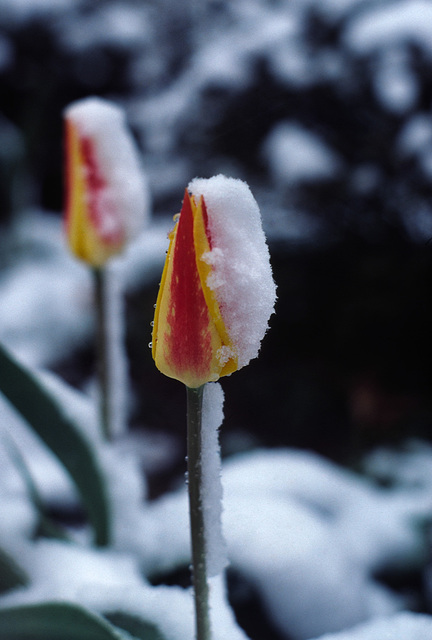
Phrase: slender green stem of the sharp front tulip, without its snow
[{"left": 186, "top": 385, "right": 211, "bottom": 640}]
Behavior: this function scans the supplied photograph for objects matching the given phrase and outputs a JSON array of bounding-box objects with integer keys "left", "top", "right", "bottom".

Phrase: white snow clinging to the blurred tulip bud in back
[{"left": 64, "top": 98, "right": 149, "bottom": 239}]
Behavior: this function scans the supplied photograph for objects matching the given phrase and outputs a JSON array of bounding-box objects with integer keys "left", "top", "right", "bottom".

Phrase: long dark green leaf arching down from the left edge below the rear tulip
[{"left": 0, "top": 345, "right": 110, "bottom": 546}]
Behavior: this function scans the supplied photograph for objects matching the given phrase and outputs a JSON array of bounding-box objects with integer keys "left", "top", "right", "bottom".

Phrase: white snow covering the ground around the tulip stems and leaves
[{"left": 0, "top": 368, "right": 432, "bottom": 640}]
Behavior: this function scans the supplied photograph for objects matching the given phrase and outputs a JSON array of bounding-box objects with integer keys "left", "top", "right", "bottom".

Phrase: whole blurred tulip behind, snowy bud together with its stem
[{"left": 64, "top": 98, "right": 148, "bottom": 438}]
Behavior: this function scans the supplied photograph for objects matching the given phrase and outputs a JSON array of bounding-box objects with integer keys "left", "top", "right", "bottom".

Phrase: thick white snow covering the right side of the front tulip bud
[{"left": 188, "top": 175, "right": 276, "bottom": 368}]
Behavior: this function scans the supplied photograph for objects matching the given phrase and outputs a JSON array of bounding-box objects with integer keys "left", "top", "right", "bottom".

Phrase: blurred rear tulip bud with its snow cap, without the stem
[{"left": 64, "top": 98, "right": 147, "bottom": 267}]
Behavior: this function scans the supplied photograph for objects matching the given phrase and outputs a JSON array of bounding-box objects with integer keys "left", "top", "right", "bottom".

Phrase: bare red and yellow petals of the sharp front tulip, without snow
[{"left": 152, "top": 190, "right": 238, "bottom": 388}]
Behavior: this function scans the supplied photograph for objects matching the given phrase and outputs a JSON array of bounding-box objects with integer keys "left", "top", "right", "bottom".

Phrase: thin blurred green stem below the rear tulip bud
[{"left": 93, "top": 267, "right": 112, "bottom": 440}]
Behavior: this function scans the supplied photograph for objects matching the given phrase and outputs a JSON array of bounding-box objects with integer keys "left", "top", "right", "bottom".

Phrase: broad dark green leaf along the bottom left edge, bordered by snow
[{"left": 0, "top": 602, "right": 135, "bottom": 640}]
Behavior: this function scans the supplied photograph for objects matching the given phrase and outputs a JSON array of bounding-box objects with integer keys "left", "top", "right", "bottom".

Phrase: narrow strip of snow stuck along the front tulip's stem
[{"left": 201, "top": 382, "right": 227, "bottom": 576}]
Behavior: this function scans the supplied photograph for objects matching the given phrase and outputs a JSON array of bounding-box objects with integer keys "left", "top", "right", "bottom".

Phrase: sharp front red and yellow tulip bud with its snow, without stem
[{"left": 152, "top": 175, "right": 276, "bottom": 388}]
